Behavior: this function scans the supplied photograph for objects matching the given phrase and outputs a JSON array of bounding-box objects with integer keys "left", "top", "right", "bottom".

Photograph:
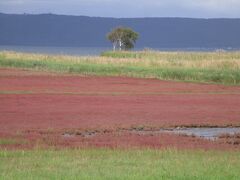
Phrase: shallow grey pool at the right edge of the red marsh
[{"left": 161, "top": 127, "right": 240, "bottom": 140}]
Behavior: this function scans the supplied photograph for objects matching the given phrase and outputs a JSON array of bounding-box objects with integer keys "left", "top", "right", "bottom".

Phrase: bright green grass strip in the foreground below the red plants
[{"left": 0, "top": 149, "right": 240, "bottom": 180}]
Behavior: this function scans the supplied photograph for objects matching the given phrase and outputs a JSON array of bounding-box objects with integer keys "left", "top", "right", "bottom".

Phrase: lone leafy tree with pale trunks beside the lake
[{"left": 107, "top": 27, "right": 138, "bottom": 51}]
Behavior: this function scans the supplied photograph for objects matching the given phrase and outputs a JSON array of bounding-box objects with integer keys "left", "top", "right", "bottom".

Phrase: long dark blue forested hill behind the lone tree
[{"left": 0, "top": 14, "right": 240, "bottom": 48}]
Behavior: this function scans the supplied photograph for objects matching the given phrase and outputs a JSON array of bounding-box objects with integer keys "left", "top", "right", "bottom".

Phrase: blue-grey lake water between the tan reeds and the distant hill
[{"left": 0, "top": 45, "right": 240, "bottom": 56}]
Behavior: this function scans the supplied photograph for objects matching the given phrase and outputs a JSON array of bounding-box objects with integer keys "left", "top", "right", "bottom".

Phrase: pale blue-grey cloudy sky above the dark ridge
[{"left": 0, "top": 0, "right": 240, "bottom": 18}]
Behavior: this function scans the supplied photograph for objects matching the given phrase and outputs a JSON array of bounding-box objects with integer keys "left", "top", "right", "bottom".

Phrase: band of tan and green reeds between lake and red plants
[{"left": 0, "top": 51, "right": 240, "bottom": 85}]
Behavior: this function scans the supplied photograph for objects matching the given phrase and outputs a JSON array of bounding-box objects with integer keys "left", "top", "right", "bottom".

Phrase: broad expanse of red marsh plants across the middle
[{"left": 0, "top": 69, "right": 240, "bottom": 150}]
